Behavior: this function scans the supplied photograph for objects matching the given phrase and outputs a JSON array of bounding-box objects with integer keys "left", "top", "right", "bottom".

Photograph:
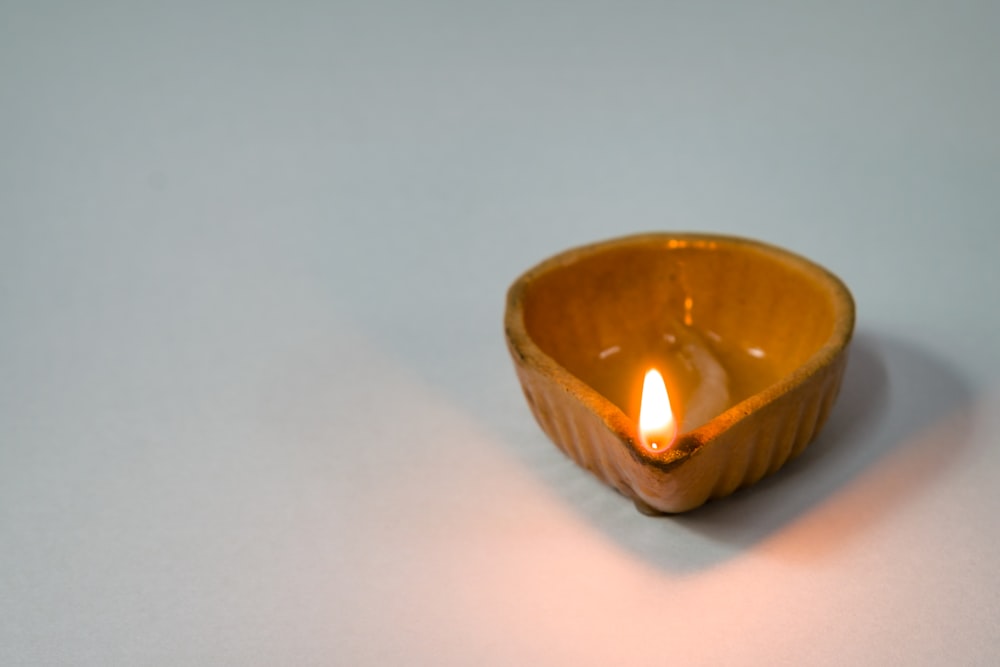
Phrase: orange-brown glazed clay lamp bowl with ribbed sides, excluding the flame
[{"left": 504, "top": 233, "right": 854, "bottom": 514}]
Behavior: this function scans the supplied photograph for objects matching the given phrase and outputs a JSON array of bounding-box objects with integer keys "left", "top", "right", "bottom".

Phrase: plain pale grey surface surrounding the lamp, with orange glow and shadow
[{"left": 0, "top": 1, "right": 1000, "bottom": 666}]
